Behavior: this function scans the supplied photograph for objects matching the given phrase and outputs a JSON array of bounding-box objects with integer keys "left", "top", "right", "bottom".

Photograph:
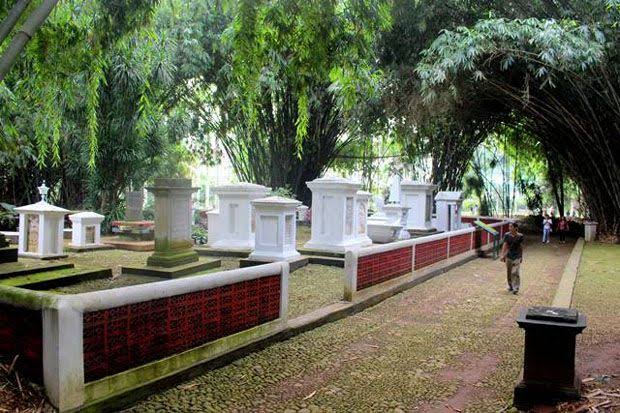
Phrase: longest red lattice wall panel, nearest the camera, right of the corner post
[{"left": 84, "top": 274, "right": 280, "bottom": 382}]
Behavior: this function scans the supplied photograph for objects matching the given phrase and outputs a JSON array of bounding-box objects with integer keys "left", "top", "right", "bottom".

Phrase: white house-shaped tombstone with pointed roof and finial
[{"left": 15, "top": 181, "right": 69, "bottom": 258}]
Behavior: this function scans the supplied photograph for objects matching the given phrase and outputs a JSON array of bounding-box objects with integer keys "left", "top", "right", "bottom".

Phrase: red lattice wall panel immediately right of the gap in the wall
[{"left": 357, "top": 247, "right": 412, "bottom": 291}]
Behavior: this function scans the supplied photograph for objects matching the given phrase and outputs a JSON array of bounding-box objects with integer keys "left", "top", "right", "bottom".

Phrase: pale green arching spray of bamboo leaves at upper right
[{"left": 416, "top": 18, "right": 605, "bottom": 99}]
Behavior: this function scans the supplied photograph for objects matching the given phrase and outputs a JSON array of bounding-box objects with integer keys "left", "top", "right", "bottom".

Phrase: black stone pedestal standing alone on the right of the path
[{"left": 514, "top": 307, "right": 586, "bottom": 410}]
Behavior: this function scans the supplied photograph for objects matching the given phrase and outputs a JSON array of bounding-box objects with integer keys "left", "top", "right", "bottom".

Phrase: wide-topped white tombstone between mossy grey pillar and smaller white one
[{"left": 207, "top": 182, "right": 269, "bottom": 249}]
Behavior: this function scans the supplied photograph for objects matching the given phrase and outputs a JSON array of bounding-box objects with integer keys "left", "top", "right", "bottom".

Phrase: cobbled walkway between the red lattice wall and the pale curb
[{"left": 133, "top": 238, "right": 572, "bottom": 412}]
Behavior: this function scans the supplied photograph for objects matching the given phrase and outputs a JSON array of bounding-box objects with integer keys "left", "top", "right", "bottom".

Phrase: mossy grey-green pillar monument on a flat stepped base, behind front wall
[{"left": 123, "top": 178, "right": 220, "bottom": 278}]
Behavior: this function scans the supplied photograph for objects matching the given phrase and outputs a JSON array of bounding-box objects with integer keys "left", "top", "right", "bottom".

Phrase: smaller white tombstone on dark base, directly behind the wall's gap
[{"left": 248, "top": 196, "right": 301, "bottom": 262}]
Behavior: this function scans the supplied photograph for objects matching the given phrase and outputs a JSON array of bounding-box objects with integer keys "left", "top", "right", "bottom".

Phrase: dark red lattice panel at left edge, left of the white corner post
[{"left": 0, "top": 304, "right": 43, "bottom": 383}]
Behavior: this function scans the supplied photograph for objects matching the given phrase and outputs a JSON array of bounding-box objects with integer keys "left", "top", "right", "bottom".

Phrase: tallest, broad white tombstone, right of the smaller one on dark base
[{"left": 305, "top": 177, "right": 362, "bottom": 253}]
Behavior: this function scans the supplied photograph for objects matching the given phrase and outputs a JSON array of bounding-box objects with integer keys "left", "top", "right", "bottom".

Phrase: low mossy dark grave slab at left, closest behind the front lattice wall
[{"left": 0, "top": 268, "right": 112, "bottom": 290}]
